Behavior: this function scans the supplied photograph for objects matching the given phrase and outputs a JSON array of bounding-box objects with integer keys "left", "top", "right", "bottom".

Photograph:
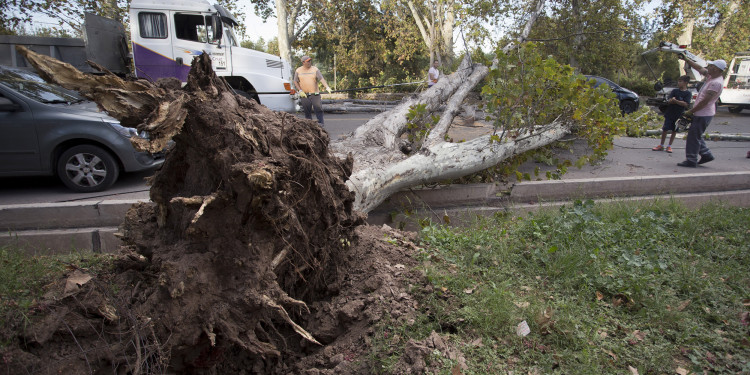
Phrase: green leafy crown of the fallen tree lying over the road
[{"left": 482, "top": 43, "right": 637, "bottom": 169}]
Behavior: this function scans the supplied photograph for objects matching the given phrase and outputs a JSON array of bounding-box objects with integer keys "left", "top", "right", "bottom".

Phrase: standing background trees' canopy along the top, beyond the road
[{"left": 5, "top": 0, "right": 750, "bottom": 89}]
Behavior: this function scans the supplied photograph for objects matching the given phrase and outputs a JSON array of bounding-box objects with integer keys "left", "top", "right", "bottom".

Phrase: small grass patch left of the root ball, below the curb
[{"left": 0, "top": 246, "right": 112, "bottom": 348}]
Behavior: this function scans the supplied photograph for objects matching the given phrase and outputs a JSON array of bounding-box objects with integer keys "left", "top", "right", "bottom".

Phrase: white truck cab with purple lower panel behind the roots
[{"left": 130, "top": 0, "right": 296, "bottom": 112}]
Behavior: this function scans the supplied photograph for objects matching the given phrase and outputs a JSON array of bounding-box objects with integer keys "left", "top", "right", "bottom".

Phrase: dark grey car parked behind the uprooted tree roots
[{"left": 0, "top": 67, "right": 164, "bottom": 192}]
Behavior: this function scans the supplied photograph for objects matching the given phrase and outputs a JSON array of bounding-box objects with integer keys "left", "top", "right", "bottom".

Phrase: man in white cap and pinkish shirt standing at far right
[{"left": 677, "top": 56, "right": 727, "bottom": 168}]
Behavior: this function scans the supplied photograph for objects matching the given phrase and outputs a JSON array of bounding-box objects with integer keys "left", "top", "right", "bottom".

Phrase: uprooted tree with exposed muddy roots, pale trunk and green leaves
[{"left": 5, "top": 2, "right": 648, "bottom": 373}]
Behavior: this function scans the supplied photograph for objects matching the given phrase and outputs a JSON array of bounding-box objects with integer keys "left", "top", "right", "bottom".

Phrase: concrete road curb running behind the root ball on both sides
[{"left": 0, "top": 172, "right": 750, "bottom": 254}]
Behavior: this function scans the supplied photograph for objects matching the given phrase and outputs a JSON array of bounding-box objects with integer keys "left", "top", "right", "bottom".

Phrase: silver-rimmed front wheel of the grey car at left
[{"left": 57, "top": 145, "right": 120, "bottom": 193}]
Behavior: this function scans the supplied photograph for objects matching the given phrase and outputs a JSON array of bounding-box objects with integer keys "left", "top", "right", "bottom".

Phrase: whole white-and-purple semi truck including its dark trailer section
[{"left": 0, "top": 0, "right": 297, "bottom": 112}]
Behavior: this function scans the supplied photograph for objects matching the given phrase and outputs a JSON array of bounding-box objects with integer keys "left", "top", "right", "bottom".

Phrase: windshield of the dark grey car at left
[{"left": 0, "top": 69, "right": 83, "bottom": 104}]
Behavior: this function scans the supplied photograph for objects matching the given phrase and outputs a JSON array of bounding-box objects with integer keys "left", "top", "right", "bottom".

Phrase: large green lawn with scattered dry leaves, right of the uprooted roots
[{"left": 371, "top": 201, "right": 750, "bottom": 374}]
